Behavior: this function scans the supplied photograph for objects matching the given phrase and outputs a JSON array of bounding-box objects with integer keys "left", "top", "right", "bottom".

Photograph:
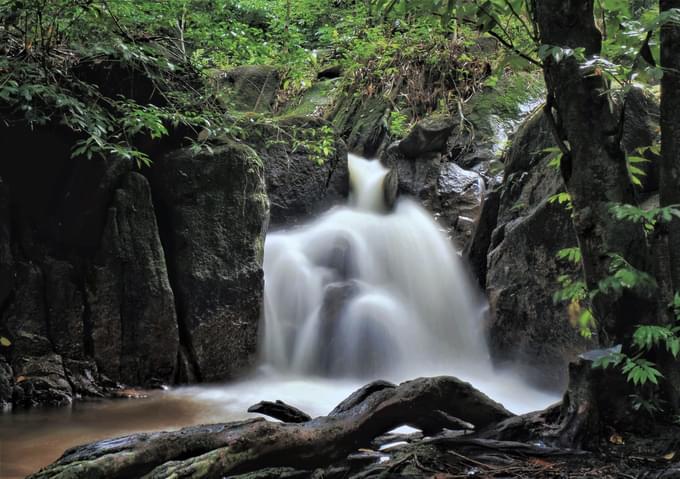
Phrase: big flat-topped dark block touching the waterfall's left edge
[{"left": 151, "top": 141, "right": 268, "bottom": 381}]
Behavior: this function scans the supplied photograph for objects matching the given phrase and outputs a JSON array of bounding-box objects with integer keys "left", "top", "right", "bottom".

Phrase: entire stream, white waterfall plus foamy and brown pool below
[{"left": 0, "top": 155, "right": 559, "bottom": 479}]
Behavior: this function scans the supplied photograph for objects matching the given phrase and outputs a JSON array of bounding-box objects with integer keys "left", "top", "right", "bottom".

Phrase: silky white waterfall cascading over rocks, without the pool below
[{"left": 261, "top": 155, "right": 490, "bottom": 380}]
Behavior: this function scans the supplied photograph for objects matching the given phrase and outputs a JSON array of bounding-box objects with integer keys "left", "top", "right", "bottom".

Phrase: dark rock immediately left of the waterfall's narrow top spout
[{"left": 248, "top": 117, "right": 349, "bottom": 227}]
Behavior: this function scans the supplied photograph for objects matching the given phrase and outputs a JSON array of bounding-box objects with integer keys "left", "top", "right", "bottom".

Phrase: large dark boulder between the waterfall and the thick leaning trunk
[{"left": 486, "top": 112, "right": 591, "bottom": 389}]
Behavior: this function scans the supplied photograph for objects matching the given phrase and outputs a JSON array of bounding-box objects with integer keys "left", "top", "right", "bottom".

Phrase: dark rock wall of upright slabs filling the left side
[{"left": 0, "top": 124, "right": 268, "bottom": 406}]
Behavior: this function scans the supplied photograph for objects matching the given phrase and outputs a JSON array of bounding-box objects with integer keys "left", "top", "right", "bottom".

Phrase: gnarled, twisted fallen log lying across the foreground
[{"left": 31, "top": 376, "right": 512, "bottom": 479}]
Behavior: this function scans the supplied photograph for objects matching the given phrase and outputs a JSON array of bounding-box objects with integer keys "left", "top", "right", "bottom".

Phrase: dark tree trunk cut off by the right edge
[{"left": 659, "top": 0, "right": 680, "bottom": 411}]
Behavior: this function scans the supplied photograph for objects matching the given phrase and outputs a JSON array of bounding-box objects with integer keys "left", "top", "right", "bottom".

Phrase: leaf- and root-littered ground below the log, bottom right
[{"left": 352, "top": 426, "right": 680, "bottom": 479}]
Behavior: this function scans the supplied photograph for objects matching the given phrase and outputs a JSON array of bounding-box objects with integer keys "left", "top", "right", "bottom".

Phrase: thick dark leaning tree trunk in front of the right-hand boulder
[{"left": 535, "top": 0, "right": 654, "bottom": 345}]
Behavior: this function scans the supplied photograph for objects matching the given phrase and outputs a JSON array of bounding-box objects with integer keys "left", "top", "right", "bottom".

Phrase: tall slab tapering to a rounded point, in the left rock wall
[{"left": 90, "top": 173, "right": 179, "bottom": 385}]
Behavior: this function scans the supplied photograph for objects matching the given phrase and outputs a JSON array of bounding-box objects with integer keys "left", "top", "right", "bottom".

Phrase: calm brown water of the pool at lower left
[{"left": 0, "top": 392, "right": 245, "bottom": 479}]
